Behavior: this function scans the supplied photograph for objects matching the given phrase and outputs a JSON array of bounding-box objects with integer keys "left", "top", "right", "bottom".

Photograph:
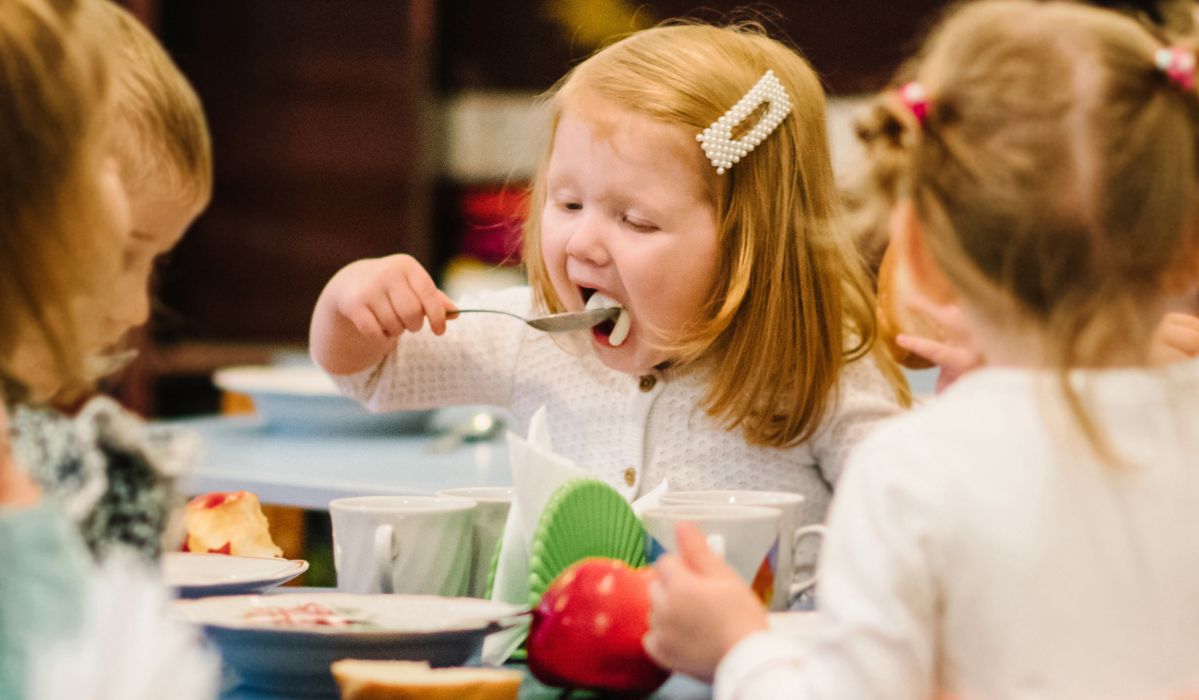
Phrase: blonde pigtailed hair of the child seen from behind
[{"left": 860, "top": 0, "right": 1199, "bottom": 461}]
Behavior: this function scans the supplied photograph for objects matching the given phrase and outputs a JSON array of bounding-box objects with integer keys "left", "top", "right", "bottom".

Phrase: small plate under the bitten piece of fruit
[{"left": 162, "top": 551, "right": 308, "bottom": 598}]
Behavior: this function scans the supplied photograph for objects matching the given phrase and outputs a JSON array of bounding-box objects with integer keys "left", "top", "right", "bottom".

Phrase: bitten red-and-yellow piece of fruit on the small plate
[{"left": 183, "top": 491, "right": 283, "bottom": 556}]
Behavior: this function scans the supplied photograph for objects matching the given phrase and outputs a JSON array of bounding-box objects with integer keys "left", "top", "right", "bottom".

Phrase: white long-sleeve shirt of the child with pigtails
[{"left": 716, "top": 361, "right": 1199, "bottom": 700}]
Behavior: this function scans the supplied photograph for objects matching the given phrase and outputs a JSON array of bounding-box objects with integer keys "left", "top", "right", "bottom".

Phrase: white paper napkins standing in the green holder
[{"left": 483, "top": 406, "right": 667, "bottom": 664}]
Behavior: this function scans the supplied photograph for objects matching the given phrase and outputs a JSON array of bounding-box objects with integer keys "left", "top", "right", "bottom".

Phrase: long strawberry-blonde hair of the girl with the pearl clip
[{"left": 525, "top": 24, "right": 906, "bottom": 447}]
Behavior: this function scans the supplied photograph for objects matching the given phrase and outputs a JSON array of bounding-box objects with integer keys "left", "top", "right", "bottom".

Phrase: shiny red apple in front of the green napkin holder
[{"left": 529, "top": 557, "right": 670, "bottom": 695}]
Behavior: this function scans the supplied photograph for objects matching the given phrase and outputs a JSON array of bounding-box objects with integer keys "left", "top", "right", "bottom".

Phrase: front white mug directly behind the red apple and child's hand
[{"left": 641, "top": 505, "right": 781, "bottom": 605}]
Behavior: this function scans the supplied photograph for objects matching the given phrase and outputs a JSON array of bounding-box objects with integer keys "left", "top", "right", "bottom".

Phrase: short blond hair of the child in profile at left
[{"left": 102, "top": 0, "right": 212, "bottom": 206}]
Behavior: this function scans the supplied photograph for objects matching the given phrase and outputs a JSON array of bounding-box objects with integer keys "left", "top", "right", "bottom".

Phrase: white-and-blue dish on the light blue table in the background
[{"left": 212, "top": 364, "right": 432, "bottom": 433}]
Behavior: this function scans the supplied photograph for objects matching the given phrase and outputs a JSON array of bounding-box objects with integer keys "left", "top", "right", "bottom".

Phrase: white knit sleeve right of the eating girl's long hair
[{"left": 812, "top": 354, "right": 903, "bottom": 488}]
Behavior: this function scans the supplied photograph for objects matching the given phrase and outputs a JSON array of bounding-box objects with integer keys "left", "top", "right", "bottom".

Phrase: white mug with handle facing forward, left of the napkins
[{"left": 329, "top": 496, "right": 475, "bottom": 596}]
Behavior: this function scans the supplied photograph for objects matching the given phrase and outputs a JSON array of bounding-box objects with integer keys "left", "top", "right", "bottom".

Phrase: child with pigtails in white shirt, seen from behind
[{"left": 645, "top": 0, "right": 1199, "bottom": 700}]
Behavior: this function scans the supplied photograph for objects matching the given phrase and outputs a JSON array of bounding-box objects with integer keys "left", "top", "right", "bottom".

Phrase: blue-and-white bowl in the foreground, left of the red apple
[{"left": 174, "top": 592, "right": 523, "bottom": 698}]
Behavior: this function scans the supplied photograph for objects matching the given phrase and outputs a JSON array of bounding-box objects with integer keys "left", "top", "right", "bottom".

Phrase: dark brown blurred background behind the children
[{"left": 114, "top": 0, "right": 945, "bottom": 416}]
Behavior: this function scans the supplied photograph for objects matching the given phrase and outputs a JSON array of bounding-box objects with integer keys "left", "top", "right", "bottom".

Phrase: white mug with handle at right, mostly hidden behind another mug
[{"left": 661, "top": 490, "right": 825, "bottom": 610}]
